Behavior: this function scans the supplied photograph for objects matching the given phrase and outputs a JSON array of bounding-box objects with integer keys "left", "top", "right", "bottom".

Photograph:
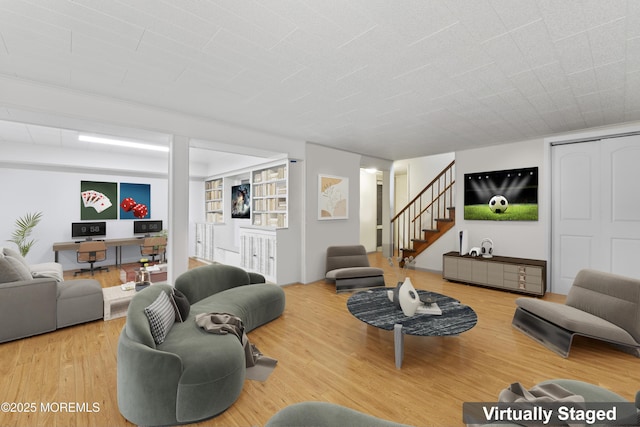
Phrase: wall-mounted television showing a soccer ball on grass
[{"left": 464, "top": 167, "right": 538, "bottom": 221}]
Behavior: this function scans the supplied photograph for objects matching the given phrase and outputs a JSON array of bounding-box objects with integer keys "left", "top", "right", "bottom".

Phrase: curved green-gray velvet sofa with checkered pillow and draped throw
[{"left": 117, "top": 264, "right": 285, "bottom": 426}]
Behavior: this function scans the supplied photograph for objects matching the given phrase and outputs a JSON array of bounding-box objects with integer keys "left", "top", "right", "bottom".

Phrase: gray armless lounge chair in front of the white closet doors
[{"left": 512, "top": 269, "right": 640, "bottom": 357}]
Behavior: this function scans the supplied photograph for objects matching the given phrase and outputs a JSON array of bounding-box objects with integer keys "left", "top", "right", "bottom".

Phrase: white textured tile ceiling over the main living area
[{"left": 0, "top": 0, "right": 640, "bottom": 159}]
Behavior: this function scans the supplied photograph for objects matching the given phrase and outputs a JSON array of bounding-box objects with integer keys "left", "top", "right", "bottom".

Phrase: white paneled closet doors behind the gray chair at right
[{"left": 551, "top": 136, "right": 640, "bottom": 294}]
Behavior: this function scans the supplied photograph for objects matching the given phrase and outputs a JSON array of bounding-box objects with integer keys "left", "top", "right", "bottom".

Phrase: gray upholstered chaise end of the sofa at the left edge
[{"left": 57, "top": 279, "right": 104, "bottom": 328}]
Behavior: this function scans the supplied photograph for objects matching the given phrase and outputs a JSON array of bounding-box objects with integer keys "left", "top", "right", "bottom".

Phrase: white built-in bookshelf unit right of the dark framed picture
[{"left": 251, "top": 163, "right": 289, "bottom": 228}]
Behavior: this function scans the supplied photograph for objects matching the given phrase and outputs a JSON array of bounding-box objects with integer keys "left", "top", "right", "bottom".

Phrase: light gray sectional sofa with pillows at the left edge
[{"left": 0, "top": 248, "right": 104, "bottom": 343}]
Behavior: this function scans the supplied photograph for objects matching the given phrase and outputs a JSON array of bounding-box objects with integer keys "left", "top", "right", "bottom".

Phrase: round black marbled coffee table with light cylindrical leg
[{"left": 347, "top": 288, "right": 478, "bottom": 369}]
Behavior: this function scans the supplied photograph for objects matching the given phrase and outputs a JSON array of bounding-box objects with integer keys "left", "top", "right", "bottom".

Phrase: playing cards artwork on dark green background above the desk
[{"left": 80, "top": 181, "right": 118, "bottom": 220}]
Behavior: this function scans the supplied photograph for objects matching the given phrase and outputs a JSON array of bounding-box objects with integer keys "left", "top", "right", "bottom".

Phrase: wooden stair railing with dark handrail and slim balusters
[{"left": 391, "top": 160, "right": 455, "bottom": 256}]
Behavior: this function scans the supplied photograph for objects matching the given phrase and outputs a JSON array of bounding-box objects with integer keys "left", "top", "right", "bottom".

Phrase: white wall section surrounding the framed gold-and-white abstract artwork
[{"left": 302, "top": 143, "right": 360, "bottom": 283}]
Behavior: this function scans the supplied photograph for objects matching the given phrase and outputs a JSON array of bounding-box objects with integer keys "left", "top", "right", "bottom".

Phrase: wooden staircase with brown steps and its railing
[{"left": 391, "top": 160, "right": 456, "bottom": 266}]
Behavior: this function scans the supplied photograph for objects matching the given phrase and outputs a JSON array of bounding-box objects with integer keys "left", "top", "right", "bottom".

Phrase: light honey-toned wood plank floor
[{"left": 0, "top": 254, "right": 640, "bottom": 426}]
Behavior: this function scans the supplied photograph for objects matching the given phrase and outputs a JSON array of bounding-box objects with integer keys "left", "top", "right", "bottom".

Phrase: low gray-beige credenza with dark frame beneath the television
[{"left": 442, "top": 252, "right": 547, "bottom": 296}]
